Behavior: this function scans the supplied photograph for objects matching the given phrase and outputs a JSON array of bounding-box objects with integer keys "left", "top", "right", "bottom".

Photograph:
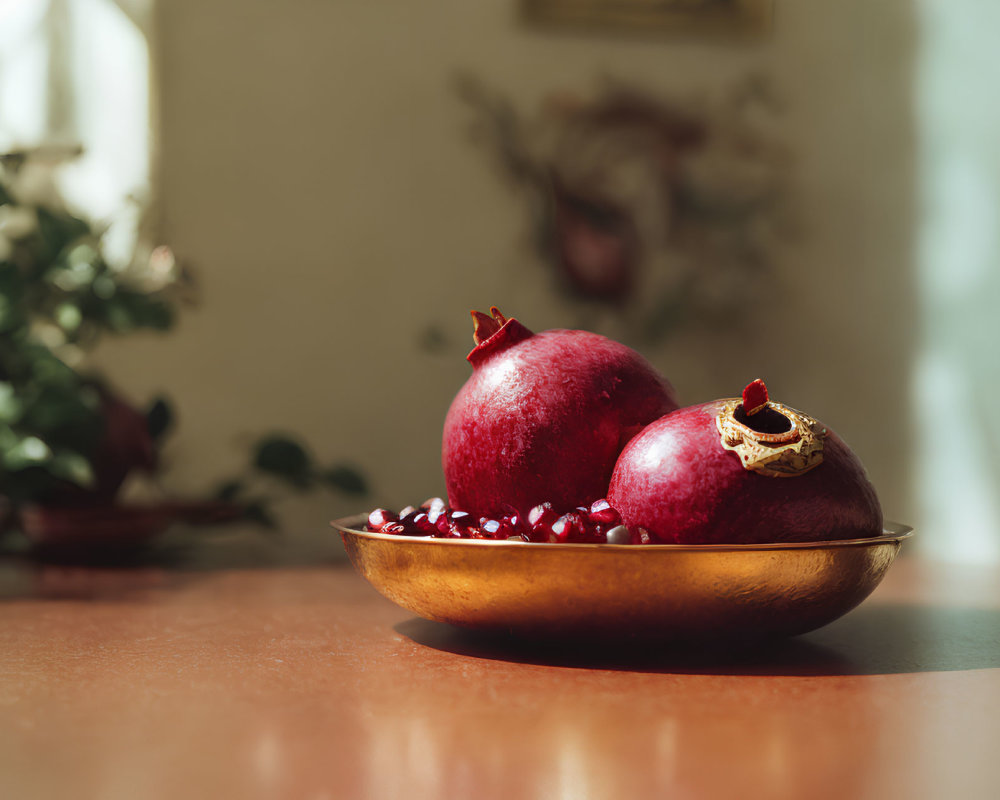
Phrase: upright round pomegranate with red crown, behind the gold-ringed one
[{"left": 442, "top": 308, "right": 677, "bottom": 517}]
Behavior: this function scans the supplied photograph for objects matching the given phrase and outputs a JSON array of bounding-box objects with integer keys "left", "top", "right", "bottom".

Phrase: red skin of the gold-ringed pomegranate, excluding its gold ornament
[{"left": 608, "top": 400, "right": 882, "bottom": 544}]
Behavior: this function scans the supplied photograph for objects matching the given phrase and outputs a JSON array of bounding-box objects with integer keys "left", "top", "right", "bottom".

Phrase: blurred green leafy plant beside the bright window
[{"left": 0, "top": 153, "right": 367, "bottom": 531}]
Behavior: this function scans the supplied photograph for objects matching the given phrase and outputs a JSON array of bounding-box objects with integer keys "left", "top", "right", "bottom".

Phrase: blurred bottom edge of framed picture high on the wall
[{"left": 521, "top": 0, "right": 773, "bottom": 36}]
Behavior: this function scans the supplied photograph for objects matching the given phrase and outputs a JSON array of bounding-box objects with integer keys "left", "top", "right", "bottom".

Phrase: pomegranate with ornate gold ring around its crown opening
[{"left": 608, "top": 381, "right": 882, "bottom": 544}]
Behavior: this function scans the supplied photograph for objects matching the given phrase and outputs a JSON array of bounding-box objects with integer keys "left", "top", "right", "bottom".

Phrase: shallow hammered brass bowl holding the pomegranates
[{"left": 332, "top": 515, "right": 912, "bottom": 640}]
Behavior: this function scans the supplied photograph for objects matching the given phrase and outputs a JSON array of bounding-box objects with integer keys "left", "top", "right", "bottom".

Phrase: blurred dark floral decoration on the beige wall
[{"left": 459, "top": 76, "right": 791, "bottom": 346}]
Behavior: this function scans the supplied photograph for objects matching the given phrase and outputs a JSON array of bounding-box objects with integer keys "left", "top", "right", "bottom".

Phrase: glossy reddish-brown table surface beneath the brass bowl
[{"left": 0, "top": 557, "right": 1000, "bottom": 800}]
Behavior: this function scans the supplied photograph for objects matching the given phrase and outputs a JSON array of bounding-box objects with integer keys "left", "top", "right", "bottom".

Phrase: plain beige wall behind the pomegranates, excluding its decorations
[{"left": 94, "top": 0, "right": 914, "bottom": 552}]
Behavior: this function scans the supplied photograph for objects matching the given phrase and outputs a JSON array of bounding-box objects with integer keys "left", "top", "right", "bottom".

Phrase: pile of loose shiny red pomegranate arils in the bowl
[{"left": 365, "top": 497, "right": 657, "bottom": 544}]
